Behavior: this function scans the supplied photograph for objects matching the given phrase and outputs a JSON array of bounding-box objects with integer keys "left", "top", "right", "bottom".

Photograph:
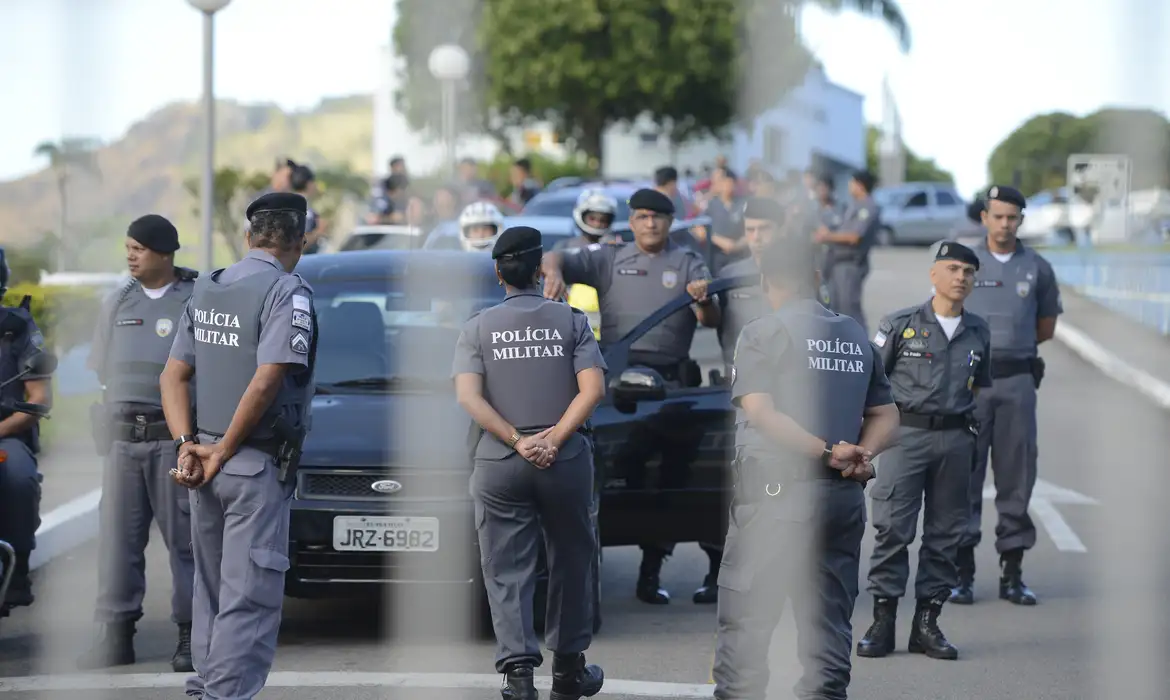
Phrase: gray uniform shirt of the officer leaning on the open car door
[{"left": 562, "top": 241, "right": 711, "bottom": 365}]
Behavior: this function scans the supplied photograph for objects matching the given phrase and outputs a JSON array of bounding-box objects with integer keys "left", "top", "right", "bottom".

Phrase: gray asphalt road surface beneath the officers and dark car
[{"left": 0, "top": 249, "right": 1170, "bottom": 700}]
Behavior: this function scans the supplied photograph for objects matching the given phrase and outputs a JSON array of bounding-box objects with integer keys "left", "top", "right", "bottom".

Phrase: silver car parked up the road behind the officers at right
[{"left": 873, "top": 183, "right": 966, "bottom": 246}]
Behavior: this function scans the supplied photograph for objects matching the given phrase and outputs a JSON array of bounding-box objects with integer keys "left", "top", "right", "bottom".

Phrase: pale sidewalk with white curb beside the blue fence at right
[{"left": 1057, "top": 287, "right": 1170, "bottom": 410}]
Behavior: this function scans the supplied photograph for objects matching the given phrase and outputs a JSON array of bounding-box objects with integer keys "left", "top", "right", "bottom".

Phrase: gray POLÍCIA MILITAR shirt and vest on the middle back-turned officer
[{"left": 452, "top": 291, "right": 608, "bottom": 460}]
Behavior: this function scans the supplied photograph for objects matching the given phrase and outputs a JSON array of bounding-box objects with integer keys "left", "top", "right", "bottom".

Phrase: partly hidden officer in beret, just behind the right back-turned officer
[{"left": 718, "top": 197, "right": 785, "bottom": 380}]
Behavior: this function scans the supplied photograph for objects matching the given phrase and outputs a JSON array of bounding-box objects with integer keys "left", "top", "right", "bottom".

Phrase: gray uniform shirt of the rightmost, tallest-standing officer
[{"left": 964, "top": 239, "right": 1064, "bottom": 359}]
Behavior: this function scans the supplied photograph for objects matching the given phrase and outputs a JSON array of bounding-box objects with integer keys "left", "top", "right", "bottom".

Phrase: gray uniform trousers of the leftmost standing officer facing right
[{"left": 94, "top": 440, "right": 195, "bottom": 624}]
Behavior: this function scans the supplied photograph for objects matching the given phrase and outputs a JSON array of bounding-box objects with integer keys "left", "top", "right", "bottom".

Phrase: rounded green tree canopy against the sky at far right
[{"left": 987, "top": 109, "right": 1170, "bottom": 195}]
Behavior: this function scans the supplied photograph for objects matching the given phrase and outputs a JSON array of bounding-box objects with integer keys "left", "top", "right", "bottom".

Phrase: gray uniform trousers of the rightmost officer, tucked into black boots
[{"left": 962, "top": 375, "right": 1038, "bottom": 553}]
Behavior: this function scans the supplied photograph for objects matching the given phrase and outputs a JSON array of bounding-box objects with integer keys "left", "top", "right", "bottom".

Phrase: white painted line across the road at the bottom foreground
[{"left": 0, "top": 671, "right": 715, "bottom": 698}]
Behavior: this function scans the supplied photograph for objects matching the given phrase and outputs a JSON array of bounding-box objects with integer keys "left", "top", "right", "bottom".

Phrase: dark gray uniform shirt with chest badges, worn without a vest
[{"left": 874, "top": 301, "right": 991, "bottom": 416}]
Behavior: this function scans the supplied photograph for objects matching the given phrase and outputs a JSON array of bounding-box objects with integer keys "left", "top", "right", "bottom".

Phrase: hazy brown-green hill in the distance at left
[{"left": 0, "top": 95, "right": 373, "bottom": 268}]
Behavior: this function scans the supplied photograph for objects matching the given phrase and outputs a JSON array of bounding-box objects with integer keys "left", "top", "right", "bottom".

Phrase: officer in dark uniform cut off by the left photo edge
[{"left": 0, "top": 248, "right": 51, "bottom": 617}]
